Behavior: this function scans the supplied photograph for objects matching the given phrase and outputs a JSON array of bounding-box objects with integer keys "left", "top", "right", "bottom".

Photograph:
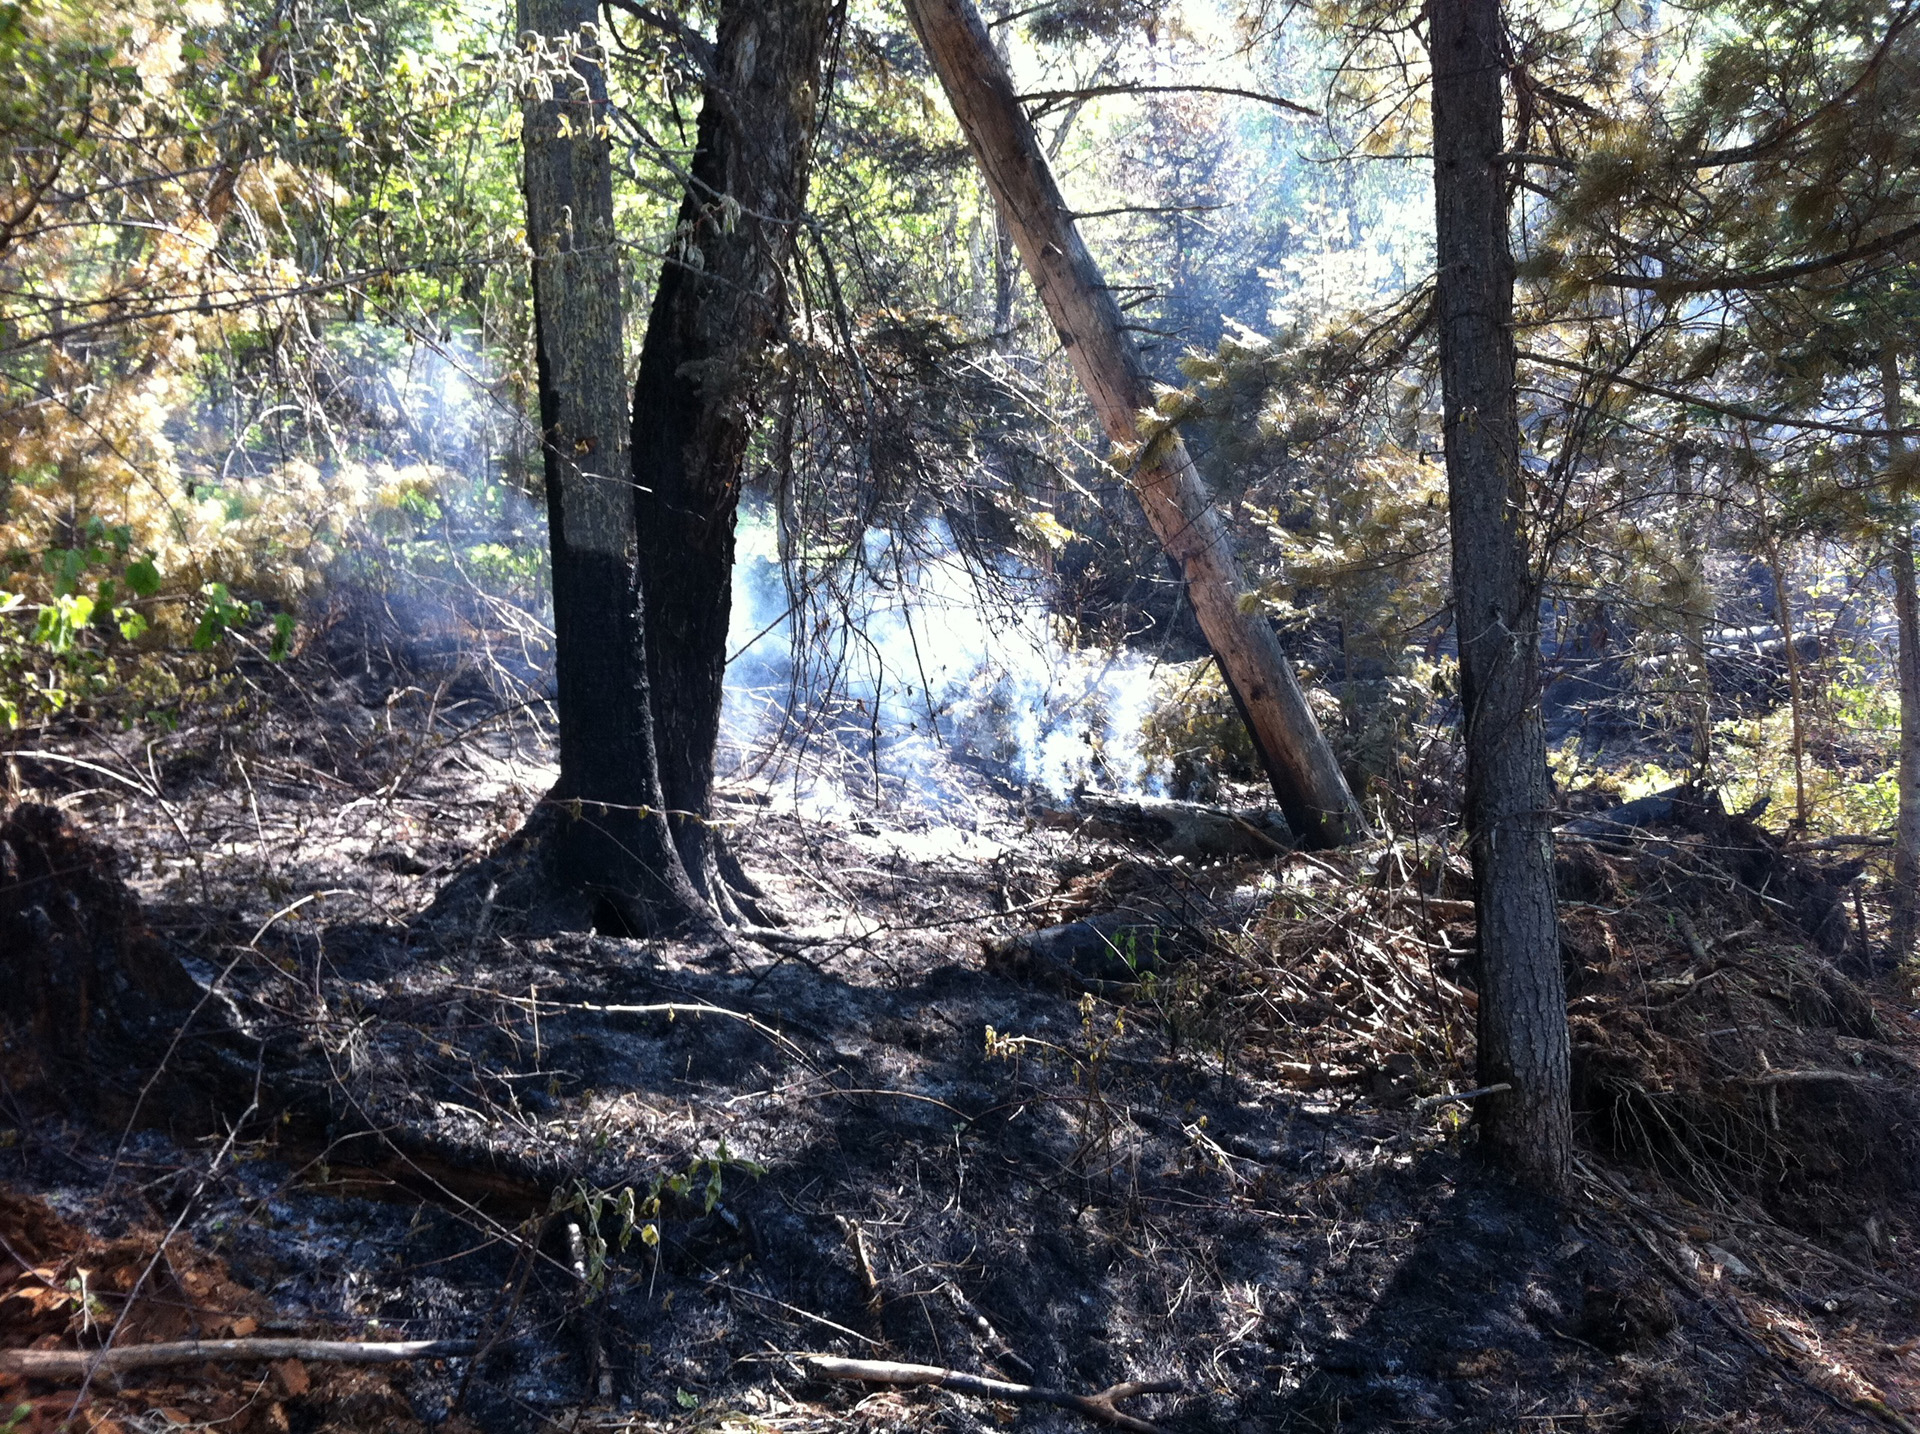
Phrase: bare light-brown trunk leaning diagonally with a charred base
[{"left": 890, "top": 0, "right": 1365, "bottom": 847}]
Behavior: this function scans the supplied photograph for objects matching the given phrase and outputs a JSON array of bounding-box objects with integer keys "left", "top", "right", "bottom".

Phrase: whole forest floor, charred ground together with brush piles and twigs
[{"left": 0, "top": 641, "right": 1920, "bottom": 1434}]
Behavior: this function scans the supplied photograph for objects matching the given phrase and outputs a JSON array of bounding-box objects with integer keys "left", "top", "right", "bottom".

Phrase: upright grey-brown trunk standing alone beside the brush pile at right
[{"left": 1428, "top": 0, "right": 1572, "bottom": 1190}]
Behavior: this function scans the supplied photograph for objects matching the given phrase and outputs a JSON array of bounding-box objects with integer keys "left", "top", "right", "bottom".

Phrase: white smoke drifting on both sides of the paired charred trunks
[{"left": 314, "top": 324, "right": 1158, "bottom": 825}]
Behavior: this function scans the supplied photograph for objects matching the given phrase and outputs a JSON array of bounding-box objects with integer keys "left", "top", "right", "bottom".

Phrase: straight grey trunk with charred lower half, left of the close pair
[{"left": 518, "top": 0, "right": 699, "bottom": 929}]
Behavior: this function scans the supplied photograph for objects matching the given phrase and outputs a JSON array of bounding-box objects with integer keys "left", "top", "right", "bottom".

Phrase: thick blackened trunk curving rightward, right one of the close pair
[{"left": 632, "top": 0, "right": 835, "bottom": 916}]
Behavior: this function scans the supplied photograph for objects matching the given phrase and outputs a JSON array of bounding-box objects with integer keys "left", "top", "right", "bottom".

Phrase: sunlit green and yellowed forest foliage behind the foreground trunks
[{"left": 0, "top": 0, "right": 1920, "bottom": 948}]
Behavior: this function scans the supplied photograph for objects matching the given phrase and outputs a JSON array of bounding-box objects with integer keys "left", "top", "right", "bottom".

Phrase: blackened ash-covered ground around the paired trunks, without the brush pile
[{"left": 0, "top": 668, "right": 1912, "bottom": 1430}]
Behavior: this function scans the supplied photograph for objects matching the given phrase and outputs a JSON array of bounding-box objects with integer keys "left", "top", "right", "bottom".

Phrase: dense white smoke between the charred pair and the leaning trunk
[{"left": 722, "top": 509, "right": 1156, "bottom": 816}]
